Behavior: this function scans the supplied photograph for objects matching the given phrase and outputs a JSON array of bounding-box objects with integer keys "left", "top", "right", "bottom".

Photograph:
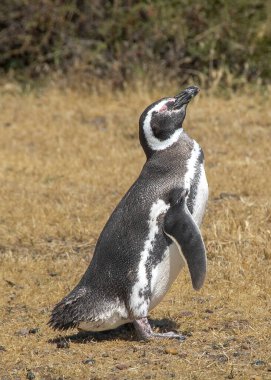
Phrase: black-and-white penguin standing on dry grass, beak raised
[{"left": 49, "top": 86, "right": 208, "bottom": 339}]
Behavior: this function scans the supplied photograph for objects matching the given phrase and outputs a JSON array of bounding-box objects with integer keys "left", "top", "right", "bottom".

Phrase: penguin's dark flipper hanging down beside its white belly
[{"left": 164, "top": 189, "right": 207, "bottom": 290}]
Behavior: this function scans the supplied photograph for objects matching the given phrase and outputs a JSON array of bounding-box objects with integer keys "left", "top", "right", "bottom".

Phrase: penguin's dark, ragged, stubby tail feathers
[{"left": 48, "top": 287, "right": 89, "bottom": 330}]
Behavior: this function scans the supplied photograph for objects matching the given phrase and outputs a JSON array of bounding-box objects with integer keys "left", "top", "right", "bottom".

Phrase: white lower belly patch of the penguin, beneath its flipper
[{"left": 149, "top": 243, "right": 185, "bottom": 310}]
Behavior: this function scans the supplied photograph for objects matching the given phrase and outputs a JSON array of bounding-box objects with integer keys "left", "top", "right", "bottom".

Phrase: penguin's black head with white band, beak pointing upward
[{"left": 139, "top": 86, "right": 199, "bottom": 155}]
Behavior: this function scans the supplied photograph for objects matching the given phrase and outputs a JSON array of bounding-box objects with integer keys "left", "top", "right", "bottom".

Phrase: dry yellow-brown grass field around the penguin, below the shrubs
[{"left": 0, "top": 81, "right": 271, "bottom": 380}]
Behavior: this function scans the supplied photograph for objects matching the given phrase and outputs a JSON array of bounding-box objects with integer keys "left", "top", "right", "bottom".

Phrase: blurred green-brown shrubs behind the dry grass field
[{"left": 0, "top": 0, "right": 271, "bottom": 88}]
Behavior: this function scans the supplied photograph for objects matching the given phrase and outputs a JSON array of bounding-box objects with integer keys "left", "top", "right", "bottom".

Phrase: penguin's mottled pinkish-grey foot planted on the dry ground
[{"left": 133, "top": 317, "right": 185, "bottom": 340}]
